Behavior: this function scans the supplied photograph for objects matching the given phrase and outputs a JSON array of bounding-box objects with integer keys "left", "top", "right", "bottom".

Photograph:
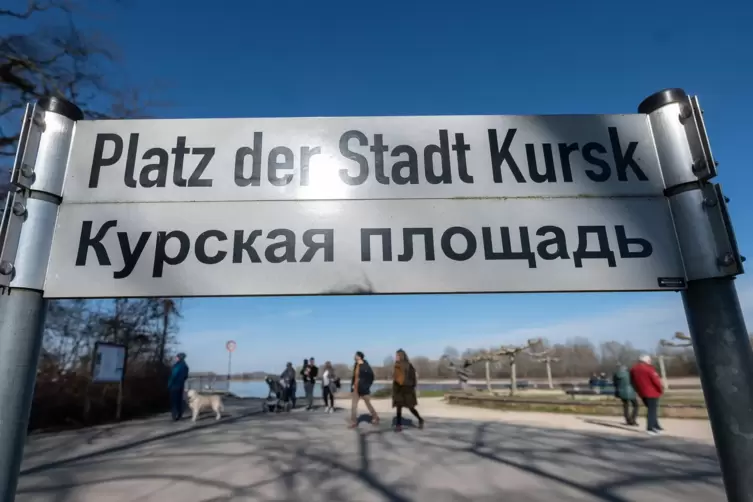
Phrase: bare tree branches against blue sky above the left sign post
[{"left": 0, "top": 0, "right": 154, "bottom": 200}]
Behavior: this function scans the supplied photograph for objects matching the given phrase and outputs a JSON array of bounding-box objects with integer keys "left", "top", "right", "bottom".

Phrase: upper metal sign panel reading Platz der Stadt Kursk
[{"left": 63, "top": 114, "right": 664, "bottom": 202}]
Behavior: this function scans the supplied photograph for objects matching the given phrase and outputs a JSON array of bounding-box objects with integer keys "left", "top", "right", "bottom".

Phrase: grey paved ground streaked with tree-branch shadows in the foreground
[{"left": 16, "top": 412, "right": 725, "bottom": 502}]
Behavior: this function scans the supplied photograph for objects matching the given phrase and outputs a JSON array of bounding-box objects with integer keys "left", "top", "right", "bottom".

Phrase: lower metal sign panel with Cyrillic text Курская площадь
[{"left": 45, "top": 197, "right": 685, "bottom": 298}]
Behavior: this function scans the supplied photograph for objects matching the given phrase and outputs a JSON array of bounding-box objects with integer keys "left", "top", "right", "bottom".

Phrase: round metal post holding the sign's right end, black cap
[{"left": 638, "top": 89, "right": 753, "bottom": 502}]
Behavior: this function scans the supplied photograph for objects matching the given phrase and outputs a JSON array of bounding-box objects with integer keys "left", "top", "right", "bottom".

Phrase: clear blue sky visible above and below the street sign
[{"left": 10, "top": 0, "right": 753, "bottom": 372}]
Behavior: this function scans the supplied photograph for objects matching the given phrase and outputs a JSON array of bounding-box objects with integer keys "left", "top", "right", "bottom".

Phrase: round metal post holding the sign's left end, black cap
[{"left": 0, "top": 98, "right": 83, "bottom": 502}]
